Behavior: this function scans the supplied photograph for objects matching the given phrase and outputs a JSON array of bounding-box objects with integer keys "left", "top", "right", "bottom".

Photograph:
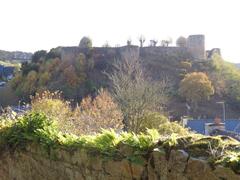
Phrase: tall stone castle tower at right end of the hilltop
[{"left": 187, "top": 34, "right": 206, "bottom": 60}]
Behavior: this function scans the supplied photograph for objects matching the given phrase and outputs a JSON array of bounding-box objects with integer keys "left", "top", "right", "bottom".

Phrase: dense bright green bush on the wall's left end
[{"left": 0, "top": 113, "right": 57, "bottom": 150}]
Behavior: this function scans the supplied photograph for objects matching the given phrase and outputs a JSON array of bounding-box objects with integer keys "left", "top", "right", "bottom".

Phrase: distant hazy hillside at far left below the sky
[{"left": 0, "top": 50, "right": 32, "bottom": 61}]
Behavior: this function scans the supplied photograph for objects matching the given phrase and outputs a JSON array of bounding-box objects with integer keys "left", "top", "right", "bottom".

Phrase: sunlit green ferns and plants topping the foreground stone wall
[{"left": 0, "top": 112, "right": 240, "bottom": 173}]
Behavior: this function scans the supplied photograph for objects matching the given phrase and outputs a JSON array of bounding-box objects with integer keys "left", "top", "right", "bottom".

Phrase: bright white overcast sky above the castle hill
[{"left": 0, "top": 0, "right": 240, "bottom": 63}]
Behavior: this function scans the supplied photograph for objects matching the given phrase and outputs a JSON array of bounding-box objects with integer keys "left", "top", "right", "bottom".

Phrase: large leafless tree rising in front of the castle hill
[{"left": 107, "top": 52, "right": 169, "bottom": 133}]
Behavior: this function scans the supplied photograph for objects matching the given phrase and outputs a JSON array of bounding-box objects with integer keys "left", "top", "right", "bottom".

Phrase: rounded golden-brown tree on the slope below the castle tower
[{"left": 179, "top": 72, "right": 214, "bottom": 110}]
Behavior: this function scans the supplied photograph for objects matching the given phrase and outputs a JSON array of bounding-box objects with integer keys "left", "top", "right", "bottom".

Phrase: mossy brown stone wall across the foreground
[{"left": 0, "top": 146, "right": 240, "bottom": 180}]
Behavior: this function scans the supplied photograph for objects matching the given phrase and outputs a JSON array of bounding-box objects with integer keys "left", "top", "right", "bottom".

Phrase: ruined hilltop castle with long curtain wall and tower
[{"left": 57, "top": 35, "right": 220, "bottom": 61}]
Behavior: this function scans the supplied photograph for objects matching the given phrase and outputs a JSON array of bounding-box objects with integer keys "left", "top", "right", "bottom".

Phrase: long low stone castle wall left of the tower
[{"left": 59, "top": 46, "right": 193, "bottom": 63}]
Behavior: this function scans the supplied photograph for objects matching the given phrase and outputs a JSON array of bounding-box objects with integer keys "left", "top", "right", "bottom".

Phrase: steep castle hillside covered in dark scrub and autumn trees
[{"left": 5, "top": 43, "right": 240, "bottom": 119}]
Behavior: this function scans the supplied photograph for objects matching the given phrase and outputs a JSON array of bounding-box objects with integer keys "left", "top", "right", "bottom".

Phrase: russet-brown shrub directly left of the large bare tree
[{"left": 73, "top": 89, "right": 123, "bottom": 134}]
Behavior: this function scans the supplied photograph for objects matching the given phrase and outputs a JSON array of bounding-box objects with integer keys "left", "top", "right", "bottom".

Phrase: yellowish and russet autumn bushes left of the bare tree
[{"left": 31, "top": 90, "right": 123, "bottom": 134}]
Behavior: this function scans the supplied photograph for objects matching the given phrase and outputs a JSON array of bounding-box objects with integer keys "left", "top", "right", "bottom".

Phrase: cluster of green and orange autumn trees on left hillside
[{"left": 11, "top": 49, "right": 96, "bottom": 101}]
